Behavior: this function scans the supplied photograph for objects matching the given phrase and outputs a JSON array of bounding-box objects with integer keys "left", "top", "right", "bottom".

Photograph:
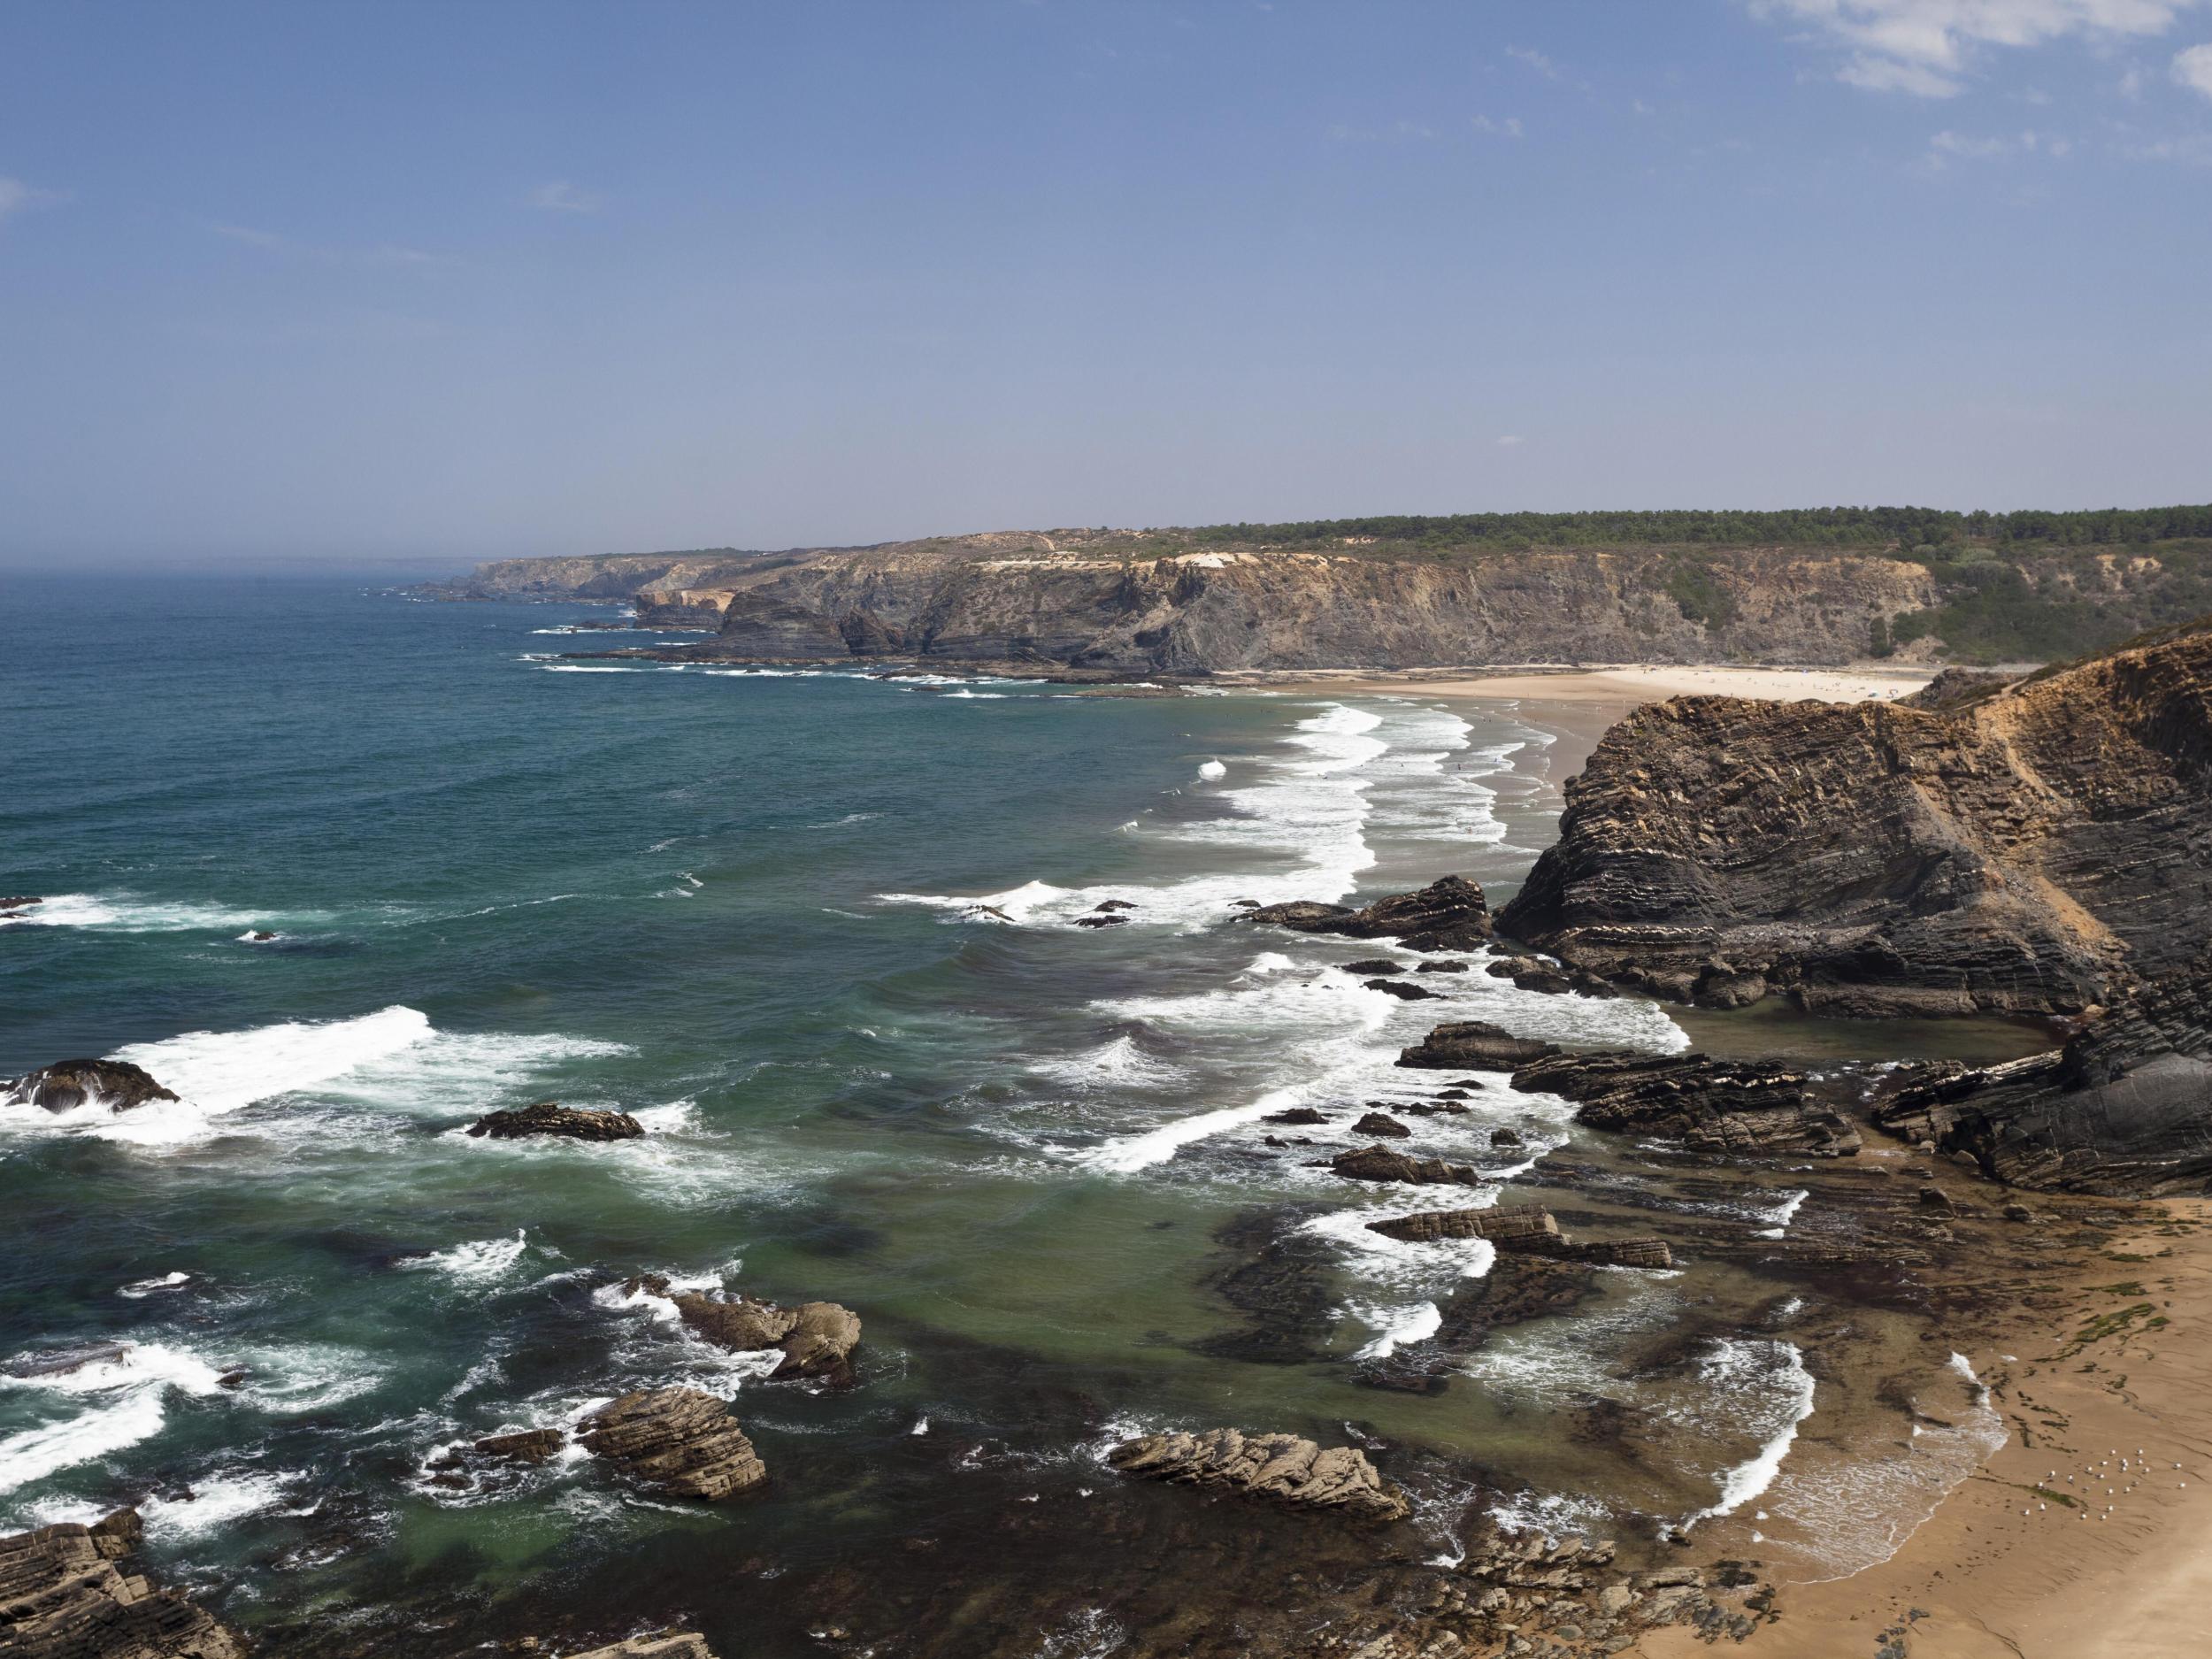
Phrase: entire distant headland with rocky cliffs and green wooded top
[{"left": 438, "top": 509, "right": 2212, "bottom": 675}]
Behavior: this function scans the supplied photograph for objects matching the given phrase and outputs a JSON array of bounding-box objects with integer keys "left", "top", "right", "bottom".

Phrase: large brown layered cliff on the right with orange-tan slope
[{"left": 1500, "top": 624, "right": 2212, "bottom": 1016}]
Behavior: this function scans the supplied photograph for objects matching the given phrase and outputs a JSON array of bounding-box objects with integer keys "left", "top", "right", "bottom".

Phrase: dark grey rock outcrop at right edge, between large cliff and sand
[{"left": 1874, "top": 958, "right": 2212, "bottom": 1197}]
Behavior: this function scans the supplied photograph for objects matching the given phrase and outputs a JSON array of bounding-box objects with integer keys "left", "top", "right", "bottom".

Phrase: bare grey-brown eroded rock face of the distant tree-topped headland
[{"left": 686, "top": 546, "right": 1933, "bottom": 675}]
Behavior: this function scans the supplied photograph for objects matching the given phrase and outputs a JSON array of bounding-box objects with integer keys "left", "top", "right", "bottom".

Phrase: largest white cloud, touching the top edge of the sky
[{"left": 1746, "top": 0, "right": 2206, "bottom": 97}]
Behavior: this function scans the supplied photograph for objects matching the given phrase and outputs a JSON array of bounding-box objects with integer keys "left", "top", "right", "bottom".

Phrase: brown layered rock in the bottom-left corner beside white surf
[{"left": 0, "top": 1509, "right": 246, "bottom": 1659}]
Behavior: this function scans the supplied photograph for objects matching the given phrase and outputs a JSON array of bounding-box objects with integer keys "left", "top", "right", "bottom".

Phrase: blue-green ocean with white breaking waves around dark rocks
[{"left": 0, "top": 578, "right": 2002, "bottom": 1655}]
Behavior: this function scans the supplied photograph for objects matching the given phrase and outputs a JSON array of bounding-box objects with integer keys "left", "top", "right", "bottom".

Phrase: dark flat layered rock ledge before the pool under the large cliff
[{"left": 1513, "top": 1051, "right": 1861, "bottom": 1157}]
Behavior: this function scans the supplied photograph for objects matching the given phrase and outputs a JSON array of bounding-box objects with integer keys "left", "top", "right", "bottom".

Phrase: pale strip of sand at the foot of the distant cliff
[{"left": 1224, "top": 664, "right": 1936, "bottom": 703}]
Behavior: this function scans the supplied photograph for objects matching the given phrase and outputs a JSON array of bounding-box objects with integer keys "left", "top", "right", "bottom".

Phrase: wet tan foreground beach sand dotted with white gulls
[{"left": 1635, "top": 1194, "right": 2212, "bottom": 1659}]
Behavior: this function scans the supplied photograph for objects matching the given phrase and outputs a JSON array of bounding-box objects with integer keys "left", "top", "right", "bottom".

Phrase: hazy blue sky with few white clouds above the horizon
[{"left": 0, "top": 0, "right": 2212, "bottom": 571}]
